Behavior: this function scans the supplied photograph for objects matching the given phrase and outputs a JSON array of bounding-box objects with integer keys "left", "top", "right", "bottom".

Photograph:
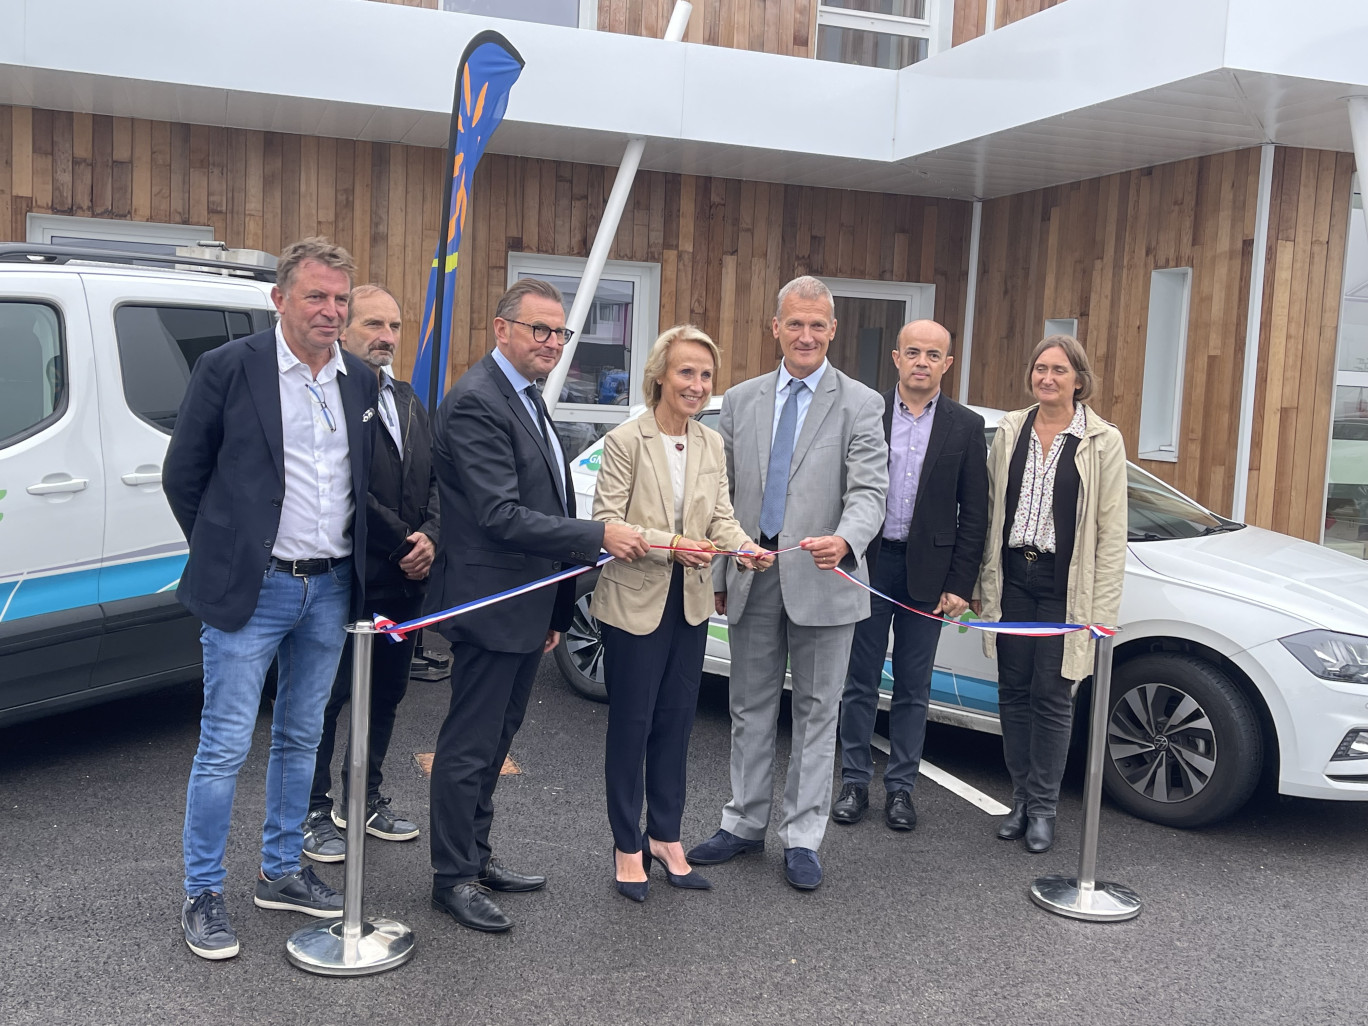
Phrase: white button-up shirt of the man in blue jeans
[{"left": 271, "top": 323, "right": 356, "bottom": 560}]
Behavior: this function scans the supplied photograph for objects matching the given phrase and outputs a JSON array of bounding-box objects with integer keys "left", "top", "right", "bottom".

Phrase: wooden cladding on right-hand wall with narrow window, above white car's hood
[{"left": 970, "top": 148, "right": 1353, "bottom": 540}]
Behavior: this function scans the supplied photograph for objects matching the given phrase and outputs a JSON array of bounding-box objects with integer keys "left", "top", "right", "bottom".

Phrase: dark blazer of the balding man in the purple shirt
[{"left": 869, "top": 386, "right": 988, "bottom": 602}]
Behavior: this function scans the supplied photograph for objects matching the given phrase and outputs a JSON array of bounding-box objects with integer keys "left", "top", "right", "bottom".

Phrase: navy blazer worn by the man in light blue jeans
[{"left": 161, "top": 328, "right": 376, "bottom": 631}]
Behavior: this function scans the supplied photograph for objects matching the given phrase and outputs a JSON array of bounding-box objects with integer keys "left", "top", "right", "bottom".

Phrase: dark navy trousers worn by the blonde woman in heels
[{"left": 602, "top": 566, "right": 707, "bottom": 852}]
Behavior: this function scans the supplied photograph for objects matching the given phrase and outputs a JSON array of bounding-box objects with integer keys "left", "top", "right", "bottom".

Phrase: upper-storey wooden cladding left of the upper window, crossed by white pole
[{"left": 598, "top": 0, "right": 817, "bottom": 57}]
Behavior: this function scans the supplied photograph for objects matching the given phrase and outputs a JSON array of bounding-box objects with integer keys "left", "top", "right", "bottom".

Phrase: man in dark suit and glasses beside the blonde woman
[{"left": 428, "top": 278, "right": 647, "bottom": 933}]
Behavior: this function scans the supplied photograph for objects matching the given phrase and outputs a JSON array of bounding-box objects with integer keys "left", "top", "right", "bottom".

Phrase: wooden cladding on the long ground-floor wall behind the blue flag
[{"left": 0, "top": 107, "right": 970, "bottom": 387}]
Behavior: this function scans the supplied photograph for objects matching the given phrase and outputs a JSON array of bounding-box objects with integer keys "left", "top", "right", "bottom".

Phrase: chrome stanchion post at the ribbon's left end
[{"left": 285, "top": 620, "right": 413, "bottom": 977}]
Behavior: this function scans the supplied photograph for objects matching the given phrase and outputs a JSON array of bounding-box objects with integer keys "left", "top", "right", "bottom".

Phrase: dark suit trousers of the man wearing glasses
[{"left": 428, "top": 643, "right": 542, "bottom": 888}]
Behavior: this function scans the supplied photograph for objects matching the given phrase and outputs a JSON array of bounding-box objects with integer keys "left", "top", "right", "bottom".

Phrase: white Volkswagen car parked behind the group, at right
[{"left": 555, "top": 397, "right": 1368, "bottom": 826}]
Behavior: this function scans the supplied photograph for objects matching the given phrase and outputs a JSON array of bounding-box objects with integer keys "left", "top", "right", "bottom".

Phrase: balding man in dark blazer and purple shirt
[{"left": 832, "top": 320, "right": 988, "bottom": 830}]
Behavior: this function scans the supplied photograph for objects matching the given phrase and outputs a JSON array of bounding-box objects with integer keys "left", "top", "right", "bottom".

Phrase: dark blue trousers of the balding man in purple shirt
[{"left": 841, "top": 539, "right": 941, "bottom": 793}]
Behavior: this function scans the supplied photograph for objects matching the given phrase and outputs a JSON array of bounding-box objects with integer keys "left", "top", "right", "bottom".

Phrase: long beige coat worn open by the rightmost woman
[{"left": 978, "top": 406, "right": 1126, "bottom": 680}]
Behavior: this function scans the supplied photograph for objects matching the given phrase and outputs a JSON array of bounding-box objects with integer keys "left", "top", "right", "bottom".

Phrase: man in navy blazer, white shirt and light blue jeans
[{"left": 163, "top": 238, "right": 376, "bottom": 959}]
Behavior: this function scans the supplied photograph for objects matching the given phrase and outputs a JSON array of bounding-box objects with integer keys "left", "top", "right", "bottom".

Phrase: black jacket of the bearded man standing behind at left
[{"left": 365, "top": 372, "right": 440, "bottom": 601}]
